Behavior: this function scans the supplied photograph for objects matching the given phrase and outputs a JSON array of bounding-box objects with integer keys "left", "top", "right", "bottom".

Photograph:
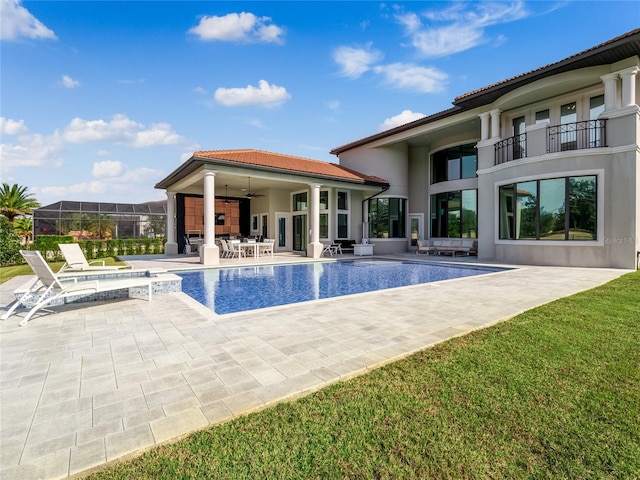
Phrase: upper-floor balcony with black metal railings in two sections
[{"left": 494, "top": 120, "right": 607, "bottom": 165}]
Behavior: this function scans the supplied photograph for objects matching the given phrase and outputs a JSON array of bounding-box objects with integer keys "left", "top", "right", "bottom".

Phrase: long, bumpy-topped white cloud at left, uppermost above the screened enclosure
[{"left": 63, "top": 114, "right": 185, "bottom": 147}]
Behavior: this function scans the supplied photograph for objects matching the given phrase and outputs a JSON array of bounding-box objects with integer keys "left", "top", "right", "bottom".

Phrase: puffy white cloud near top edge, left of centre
[{"left": 189, "top": 12, "right": 284, "bottom": 44}]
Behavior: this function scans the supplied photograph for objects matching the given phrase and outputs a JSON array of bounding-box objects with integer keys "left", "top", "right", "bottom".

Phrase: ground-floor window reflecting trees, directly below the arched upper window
[{"left": 431, "top": 190, "right": 478, "bottom": 238}]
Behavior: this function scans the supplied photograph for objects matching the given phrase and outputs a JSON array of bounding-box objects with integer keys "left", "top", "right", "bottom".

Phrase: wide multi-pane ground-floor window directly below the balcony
[{"left": 499, "top": 175, "right": 597, "bottom": 240}]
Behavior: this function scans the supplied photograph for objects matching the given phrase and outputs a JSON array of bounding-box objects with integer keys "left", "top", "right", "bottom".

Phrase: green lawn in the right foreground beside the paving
[{"left": 84, "top": 272, "right": 640, "bottom": 479}]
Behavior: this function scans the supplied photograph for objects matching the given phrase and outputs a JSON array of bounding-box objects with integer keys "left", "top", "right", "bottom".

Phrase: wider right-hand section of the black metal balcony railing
[{"left": 547, "top": 120, "right": 607, "bottom": 153}]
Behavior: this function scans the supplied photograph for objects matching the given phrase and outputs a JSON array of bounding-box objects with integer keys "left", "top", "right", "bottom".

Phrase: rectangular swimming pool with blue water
[{"left": 174, "top": 259, "right": 504, "bottom": 315}]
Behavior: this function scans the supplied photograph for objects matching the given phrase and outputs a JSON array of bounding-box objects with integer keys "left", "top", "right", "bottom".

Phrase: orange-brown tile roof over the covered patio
[{"left": 193, "top": 149, "right": 389, "bottom": 185}]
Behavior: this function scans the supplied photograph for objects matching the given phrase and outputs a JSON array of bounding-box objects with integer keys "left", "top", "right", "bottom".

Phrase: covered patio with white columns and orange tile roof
[{"left": 156, "top": 150, "right": 389, "bottom": 265}]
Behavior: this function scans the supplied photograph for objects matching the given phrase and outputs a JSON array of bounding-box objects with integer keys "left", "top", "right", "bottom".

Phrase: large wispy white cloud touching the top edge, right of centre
[{"left": 396, "top": 1, "right": 528, "bottom": 58}]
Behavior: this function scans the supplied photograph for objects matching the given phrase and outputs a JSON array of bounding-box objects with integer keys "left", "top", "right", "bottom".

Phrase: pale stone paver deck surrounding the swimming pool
[{"left": 0, "top": 254, "right": 629, "bottom": 480}]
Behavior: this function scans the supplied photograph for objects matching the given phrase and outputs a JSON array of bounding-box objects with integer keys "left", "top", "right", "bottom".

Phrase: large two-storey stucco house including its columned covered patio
[{"left": 156, "top": 29, "right": 640, "bottom": 268}]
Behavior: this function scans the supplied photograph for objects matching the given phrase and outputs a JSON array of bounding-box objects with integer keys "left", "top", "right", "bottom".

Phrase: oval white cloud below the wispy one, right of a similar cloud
[{"left": 374, "top": 63, "right": 449, "bottom": 93}]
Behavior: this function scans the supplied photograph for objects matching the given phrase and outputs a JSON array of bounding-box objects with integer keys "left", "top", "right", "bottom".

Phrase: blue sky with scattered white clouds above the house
[{"left": 0, "top": 0, "right": 640, "bottom": 205}]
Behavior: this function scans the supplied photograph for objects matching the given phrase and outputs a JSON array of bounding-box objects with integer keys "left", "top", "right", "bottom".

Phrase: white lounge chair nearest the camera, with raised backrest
[{"left": 1, "top": 250, "right": 152, "bottom": 327}]
